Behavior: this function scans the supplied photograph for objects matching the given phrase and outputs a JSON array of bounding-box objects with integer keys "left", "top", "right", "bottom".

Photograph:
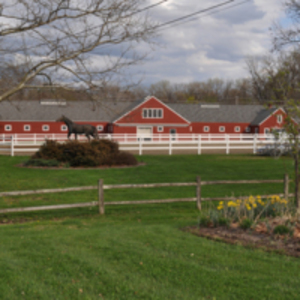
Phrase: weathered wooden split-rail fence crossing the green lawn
[{"left": 0, "top": 174, "right": 294, "bottom": 215}]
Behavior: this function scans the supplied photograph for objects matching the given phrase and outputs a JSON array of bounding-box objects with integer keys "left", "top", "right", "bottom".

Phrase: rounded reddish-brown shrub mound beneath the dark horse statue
[{"left": 25, "top": 140, "right": 138, "bottom": 167}]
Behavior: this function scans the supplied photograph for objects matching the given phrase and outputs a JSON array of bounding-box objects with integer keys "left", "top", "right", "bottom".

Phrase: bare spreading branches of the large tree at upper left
[{"left": 0, "top": 0, "right": 165, "bottom": 101}]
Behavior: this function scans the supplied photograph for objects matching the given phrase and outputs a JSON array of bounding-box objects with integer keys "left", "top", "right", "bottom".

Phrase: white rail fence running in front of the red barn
[{"left": 0, "top": 134, "right": 286, "bottom": 156}]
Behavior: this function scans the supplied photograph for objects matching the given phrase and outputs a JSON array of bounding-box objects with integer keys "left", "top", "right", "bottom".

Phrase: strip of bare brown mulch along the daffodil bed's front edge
[{"left": 183, "top": 226, "right": 300, "bottom": 257}]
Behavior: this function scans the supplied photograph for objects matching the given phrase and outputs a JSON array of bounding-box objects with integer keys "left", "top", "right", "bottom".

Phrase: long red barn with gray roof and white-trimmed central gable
[{"left": 0, "top": 96, "right": 286, "bottom": 136}]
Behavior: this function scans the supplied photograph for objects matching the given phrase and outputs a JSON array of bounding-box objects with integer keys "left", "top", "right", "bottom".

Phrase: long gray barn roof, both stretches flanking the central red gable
[{"left": 0, "top": 99, "right": 276, "bottom": 125}]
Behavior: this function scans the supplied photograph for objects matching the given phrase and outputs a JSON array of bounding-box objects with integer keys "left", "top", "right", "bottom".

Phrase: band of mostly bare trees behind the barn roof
[{"left": 0, "top": 49, "right": 300, "bottom": 104}]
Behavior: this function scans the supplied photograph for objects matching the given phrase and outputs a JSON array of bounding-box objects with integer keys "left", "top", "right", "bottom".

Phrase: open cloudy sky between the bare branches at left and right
[{"left": 128, "top": 0, "right": 284, "bottom": 85}]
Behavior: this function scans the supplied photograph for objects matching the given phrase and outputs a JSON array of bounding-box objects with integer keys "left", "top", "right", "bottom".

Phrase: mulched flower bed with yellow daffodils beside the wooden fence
[{"left": 187, "top": 196, "right": 300, "bottom": 256}]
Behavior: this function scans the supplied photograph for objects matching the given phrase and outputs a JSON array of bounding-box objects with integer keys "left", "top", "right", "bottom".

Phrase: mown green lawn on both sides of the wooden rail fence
[{"left": 0, "top": 155, "right": 300, "bottom": 300}]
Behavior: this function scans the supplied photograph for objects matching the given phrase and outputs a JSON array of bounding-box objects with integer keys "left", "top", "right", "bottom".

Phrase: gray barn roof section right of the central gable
[{"left": 168, "top": 103, "right": 264, "bottom": 123}]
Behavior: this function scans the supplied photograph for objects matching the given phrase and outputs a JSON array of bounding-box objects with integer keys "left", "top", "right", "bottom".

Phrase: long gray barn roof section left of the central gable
[{"left": 0, "top": 100, "right": 131, "bottom": 122}]
